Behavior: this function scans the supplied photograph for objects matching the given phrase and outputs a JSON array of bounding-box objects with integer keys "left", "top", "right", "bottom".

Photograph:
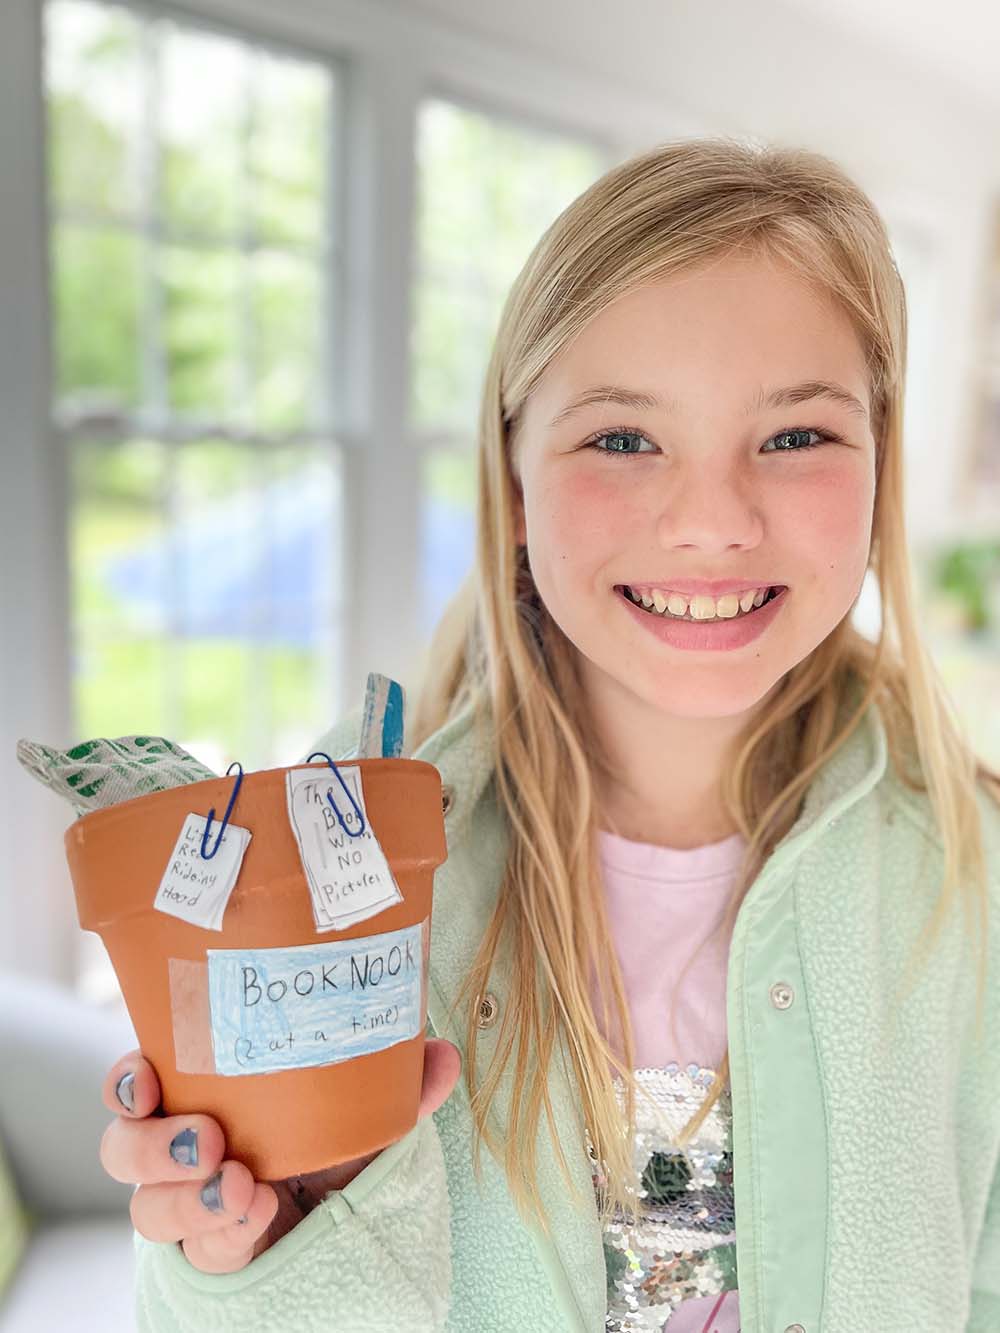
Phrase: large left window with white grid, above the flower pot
[{"left": 45, "top": 0, "right": 343, "bottom": 990}]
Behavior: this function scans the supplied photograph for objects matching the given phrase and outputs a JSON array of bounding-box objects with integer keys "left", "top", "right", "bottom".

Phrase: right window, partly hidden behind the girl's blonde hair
[{"left": 409, "top": 99, "right": 611, "bottom": 632}]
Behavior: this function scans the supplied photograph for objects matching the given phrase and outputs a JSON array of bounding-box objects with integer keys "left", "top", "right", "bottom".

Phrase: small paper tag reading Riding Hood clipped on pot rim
[{"left": 153, "top": 814, "right": 252, "bottom": 930}]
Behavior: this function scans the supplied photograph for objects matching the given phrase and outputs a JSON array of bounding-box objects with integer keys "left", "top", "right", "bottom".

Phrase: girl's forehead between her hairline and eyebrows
[{"left": 525, "top": 259, "right": 868, "bottom": 427}]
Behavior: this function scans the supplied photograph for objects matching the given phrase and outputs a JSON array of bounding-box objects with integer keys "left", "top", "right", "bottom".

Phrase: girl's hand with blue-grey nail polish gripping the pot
[{"left": 100, "top": 1037, "right": 461, "bottom": 1273}]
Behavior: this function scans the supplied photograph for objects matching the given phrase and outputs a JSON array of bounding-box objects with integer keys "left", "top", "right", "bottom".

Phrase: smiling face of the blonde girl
[{"left": 512, "top": 257, "right": 875, "bottom": 718}]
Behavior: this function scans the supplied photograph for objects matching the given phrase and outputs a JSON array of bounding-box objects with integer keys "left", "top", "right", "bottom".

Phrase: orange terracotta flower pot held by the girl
[{"left": 65, "top": 758, "right": 448, "bottom": 1180}]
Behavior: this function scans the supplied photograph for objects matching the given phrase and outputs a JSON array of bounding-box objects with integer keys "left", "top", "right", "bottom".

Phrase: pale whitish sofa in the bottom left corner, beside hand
[{"left": 0, "top": 973, "right": 139, "bottom": 1333}]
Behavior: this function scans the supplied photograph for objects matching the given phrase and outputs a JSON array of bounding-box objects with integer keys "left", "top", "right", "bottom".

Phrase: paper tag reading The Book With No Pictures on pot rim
[{"left": 287, "top": 764, "right": 403, "bottom": 930}]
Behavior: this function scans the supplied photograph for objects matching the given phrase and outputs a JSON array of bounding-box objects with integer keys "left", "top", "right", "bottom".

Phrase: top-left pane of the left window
[{"left": 45, "top": 0, "right": 143, "bottom": 216}]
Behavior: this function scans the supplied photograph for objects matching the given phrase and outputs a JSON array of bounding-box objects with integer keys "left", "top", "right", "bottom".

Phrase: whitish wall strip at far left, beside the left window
[{"left": 0, "top": 0, "right": 73, "bottom": 976}]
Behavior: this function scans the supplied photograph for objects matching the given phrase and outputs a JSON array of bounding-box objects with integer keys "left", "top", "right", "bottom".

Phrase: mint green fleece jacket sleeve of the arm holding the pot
[{"left": 135, "top": 709, "right": 452, "bottom": 1333}]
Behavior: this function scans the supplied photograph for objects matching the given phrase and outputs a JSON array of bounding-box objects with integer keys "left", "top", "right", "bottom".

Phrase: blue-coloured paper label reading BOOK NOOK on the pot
[{"left": 207, "top": 921, "right": 429, "bottom": 1074}]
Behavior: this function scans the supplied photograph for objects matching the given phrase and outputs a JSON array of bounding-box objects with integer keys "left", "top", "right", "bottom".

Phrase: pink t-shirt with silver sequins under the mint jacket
[{"left": 592, "top": 829, "right": 745, "bottom": 1333}]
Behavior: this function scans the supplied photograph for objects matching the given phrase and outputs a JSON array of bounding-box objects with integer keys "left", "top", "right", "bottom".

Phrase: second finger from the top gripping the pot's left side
[{"left": 100, "top": 1116, "right": 225, "bottom": 1185}]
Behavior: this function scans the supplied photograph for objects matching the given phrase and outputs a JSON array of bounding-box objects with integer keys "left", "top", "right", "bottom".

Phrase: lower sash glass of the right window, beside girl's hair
[{"left": 420, "top": 447, "right": 476, "bottom": 636}]
